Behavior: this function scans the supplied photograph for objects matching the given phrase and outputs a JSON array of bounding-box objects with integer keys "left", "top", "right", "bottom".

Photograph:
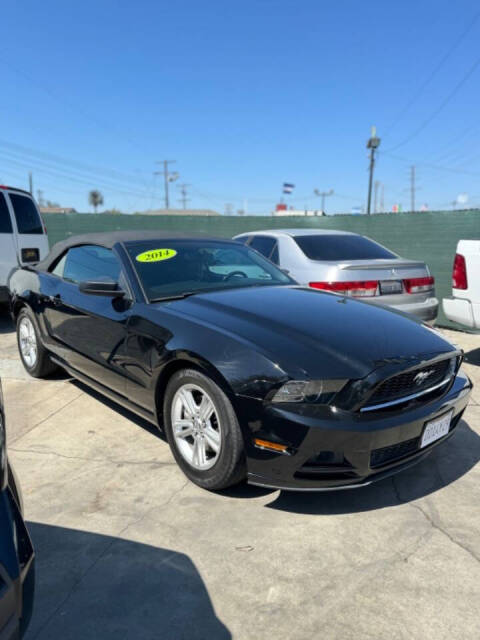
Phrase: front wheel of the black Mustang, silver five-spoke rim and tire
[{"left": 163, "top": 369, "right": 246, "bottom": 491}]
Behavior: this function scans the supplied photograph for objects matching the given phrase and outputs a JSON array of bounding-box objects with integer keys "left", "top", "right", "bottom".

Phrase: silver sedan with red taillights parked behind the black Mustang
[{"left": 235, "top": 229, "right": 438, "bottom": 322}]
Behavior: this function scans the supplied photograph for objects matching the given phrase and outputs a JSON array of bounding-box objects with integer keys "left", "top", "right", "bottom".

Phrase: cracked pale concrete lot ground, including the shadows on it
[{"left": 0, "top": 319, "right": 480, "bottom": 640}]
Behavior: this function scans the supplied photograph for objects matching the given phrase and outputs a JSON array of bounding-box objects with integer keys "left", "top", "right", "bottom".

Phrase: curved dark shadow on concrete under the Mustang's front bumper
[{"left": 265, "top": 420, "right": 480, "bottom": 515}]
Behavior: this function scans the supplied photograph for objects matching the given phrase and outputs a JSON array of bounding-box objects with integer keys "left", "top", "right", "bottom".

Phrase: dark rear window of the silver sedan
[{"left": 294, "top": 234, "right": 398, "bottom": 261}]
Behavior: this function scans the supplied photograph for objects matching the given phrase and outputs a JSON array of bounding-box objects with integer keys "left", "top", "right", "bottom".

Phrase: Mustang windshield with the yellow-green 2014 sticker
[{"left": 126, "top": 239, "right": 294, "bottom": 302}]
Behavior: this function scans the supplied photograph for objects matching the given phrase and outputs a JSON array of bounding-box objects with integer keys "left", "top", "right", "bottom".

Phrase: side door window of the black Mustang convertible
[{"left": 61, "top": 245, "right": 121, "bottom": 284}]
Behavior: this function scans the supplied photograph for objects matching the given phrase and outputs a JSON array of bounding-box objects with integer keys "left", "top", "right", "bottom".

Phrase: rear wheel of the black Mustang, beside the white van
[{"left": 17, "top": 307, "right": 57, "bottom": 378}]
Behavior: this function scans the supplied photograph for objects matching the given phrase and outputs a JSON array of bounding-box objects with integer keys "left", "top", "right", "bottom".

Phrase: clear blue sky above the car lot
[{"left": 0, "top": 0, "right": 480, "bottom": 213}]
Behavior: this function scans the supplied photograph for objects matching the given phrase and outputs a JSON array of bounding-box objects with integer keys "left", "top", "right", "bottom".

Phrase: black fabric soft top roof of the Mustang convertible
[{"left": 35, "top": 229, "right": 236, "bottom": 271}]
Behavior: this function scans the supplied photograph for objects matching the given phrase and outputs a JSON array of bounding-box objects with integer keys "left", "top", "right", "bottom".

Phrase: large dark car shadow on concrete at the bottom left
[{"left": 25, "top": 522, "right": 232, "bottom": 640}]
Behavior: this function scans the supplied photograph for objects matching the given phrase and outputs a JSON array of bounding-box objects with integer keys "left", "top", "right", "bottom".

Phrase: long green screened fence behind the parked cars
[{"left": 44, "top": 209, "right": 480, "bottom": 324}]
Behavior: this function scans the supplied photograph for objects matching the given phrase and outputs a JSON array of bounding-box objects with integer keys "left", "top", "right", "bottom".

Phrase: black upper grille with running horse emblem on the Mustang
[{"left": 368, "top": 359, "right": 450, "bottom": 406}]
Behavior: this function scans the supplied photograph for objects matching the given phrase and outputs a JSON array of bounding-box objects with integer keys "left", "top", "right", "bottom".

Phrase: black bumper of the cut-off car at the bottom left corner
[{"left": 0, "top": 489, "right": 35, "bottom": 640}]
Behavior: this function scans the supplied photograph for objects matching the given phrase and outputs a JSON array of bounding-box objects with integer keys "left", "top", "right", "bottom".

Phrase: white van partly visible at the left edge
[{"left": 0, "top": 185, "right": 49, "bottom": 303}]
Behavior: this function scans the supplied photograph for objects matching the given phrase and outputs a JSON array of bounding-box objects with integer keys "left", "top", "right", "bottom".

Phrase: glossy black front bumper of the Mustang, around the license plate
[{"left": 247, "top": 372, "right": 472, "bottom": 491}]
